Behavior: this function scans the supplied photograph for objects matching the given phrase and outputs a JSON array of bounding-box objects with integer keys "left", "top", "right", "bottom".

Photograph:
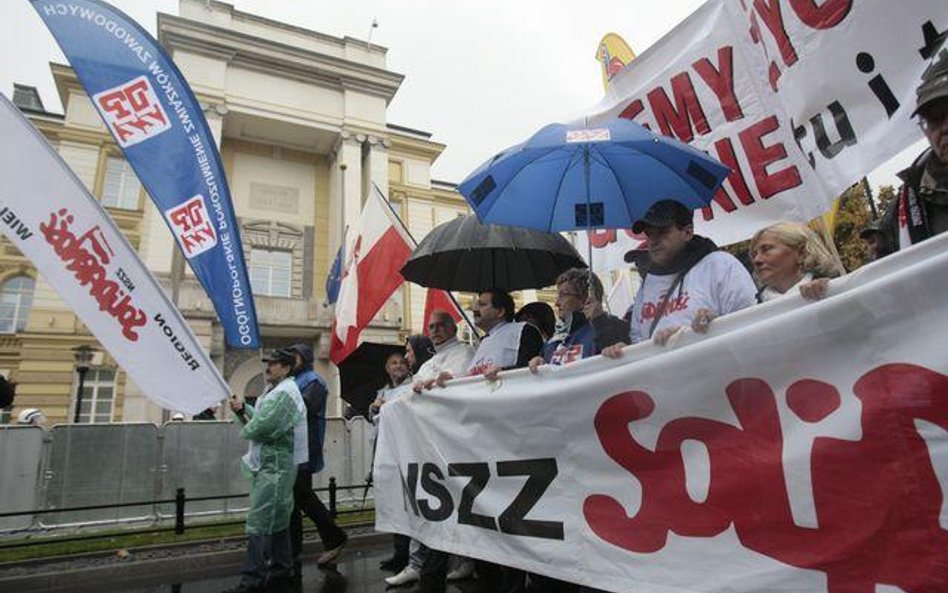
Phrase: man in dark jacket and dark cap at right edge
[{"left": 883, "top": 49, "right": 948, "bottom": 250}]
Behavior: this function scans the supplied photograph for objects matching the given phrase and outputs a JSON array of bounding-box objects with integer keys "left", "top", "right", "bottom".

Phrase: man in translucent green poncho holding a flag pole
[{"left": 225, "top": 350, "right": 306, "bottom": 593}]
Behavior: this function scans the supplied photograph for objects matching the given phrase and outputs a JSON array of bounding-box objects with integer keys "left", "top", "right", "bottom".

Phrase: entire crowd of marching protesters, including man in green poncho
[{"left": 209, "top": 49, "right": 948, "bottom": 593}]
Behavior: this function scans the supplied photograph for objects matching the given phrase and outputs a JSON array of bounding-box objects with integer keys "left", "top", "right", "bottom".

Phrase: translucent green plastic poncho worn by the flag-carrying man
[{"left": 240, "top": 377, "right": 304, "bottom": 535}]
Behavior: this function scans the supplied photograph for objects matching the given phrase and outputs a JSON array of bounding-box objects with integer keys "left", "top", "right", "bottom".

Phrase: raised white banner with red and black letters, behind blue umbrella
[{"left": 576, "top": 0, "right": 948, "bottom": 270}]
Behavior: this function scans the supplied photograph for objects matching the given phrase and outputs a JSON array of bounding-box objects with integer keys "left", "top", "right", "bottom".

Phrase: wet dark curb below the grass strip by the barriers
[{"left": 0, "top": 533, "right": 391, "bottom": 593}]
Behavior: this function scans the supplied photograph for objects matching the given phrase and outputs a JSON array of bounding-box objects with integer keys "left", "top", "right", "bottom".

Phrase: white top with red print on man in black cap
[{"left": 629, "top": 251, "right": 757, "bottom": 344}]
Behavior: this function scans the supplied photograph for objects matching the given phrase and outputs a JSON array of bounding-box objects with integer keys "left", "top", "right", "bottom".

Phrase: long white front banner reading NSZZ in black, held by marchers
[{"left": 373, "top": 235, "right": 948, "bottom": 593}]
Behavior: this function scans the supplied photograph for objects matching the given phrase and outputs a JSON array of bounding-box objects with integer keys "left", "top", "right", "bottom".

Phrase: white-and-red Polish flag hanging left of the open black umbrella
[{"left": 329, "top": 185, "right": 412, "bottom": 364}]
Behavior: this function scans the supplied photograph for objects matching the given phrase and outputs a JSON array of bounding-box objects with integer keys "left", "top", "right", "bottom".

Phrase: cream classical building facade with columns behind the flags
[{"left": 0, "top": 0, "right": 467, "bottom": 423}]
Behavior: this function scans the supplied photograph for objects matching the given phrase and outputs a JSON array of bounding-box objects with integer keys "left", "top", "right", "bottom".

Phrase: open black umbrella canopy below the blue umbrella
[{"left": 401, "top": 214, "right": 586, "bottom": 292}]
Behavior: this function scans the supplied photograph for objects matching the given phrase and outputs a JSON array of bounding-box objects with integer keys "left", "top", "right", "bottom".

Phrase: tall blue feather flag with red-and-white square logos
[{"left": 31, "top": 0, "right": 260, "bottom": 348}]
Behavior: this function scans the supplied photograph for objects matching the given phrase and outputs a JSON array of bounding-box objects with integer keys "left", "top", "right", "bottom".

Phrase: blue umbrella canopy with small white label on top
[{"left": 458, "top": 118, "right": 729, "bottom": 231}]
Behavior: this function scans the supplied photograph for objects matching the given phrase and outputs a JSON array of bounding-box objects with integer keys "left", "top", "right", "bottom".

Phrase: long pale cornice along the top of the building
[{"left": 158, "top": 13, "right": 405, "bottom": 104}]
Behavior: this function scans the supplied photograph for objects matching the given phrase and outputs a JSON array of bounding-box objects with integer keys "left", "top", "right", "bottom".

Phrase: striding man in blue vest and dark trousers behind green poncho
[{"left": 286, "top": 344, "right": 346, "bottom": 578}]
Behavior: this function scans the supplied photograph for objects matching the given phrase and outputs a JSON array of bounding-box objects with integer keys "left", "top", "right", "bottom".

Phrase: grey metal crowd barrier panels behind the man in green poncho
[{"left": 0, "top": 418, "right": 372, "bottom": 534}]
